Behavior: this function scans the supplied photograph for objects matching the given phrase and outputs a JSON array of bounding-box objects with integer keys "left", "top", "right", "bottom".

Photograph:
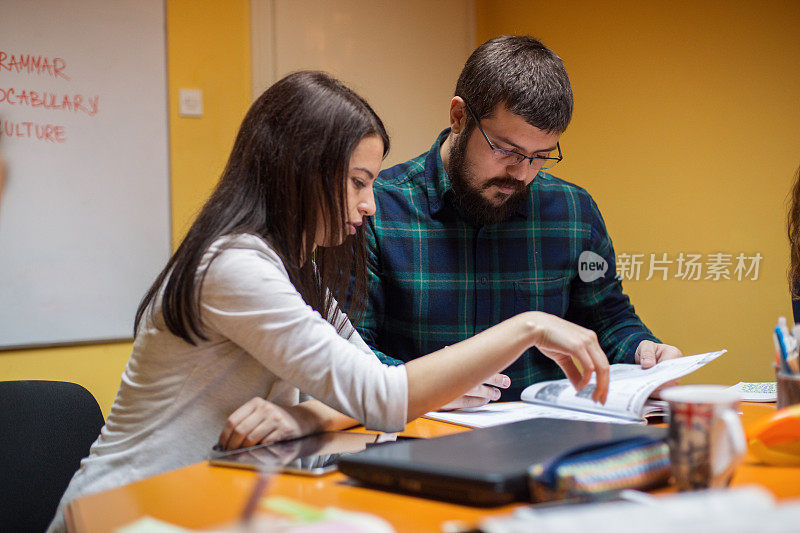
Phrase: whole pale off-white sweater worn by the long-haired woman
[{"left": 49, "top": 235, "right": 408, "bottom": 531}]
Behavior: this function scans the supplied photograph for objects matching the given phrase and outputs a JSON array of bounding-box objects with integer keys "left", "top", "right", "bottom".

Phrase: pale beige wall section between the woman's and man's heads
[{"left": 251, "top": 0, "right": 475, "bottom": 166}]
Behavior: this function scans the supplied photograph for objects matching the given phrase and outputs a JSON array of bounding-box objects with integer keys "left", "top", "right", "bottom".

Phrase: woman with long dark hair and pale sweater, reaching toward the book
[{"left": 51, "top": 72, "right": 608, "bottom": 530}]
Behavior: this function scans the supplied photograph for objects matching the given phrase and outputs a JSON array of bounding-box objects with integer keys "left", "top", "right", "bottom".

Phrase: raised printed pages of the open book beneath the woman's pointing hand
[{"left": 522, "top": 350, "right": 726, "bottom": 420}]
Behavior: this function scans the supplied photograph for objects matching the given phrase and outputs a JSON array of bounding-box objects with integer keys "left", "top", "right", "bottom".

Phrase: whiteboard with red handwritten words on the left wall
[{"left": 0, "top": 0, "right": 170, "bottom": 348}]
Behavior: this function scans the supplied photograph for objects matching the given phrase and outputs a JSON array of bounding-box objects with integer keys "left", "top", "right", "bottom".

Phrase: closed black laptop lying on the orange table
[{"left": 339, "top": 418, "right": 666, "bottom": 506}]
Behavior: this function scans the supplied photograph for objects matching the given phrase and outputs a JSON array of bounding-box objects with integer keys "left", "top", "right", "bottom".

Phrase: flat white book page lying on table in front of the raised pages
[{"left": 425, "top": 402, "right": 637, "bottom": 428}]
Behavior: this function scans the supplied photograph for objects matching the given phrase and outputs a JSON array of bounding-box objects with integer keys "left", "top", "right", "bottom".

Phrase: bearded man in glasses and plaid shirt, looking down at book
[{"left": 358, "top": 36, "right": 681, "bottom": 408}]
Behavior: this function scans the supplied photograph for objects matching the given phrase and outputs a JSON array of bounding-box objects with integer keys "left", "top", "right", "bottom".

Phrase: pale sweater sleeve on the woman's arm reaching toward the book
[{"left": 195, "top": 240, "right": 408, "bottom": 432}]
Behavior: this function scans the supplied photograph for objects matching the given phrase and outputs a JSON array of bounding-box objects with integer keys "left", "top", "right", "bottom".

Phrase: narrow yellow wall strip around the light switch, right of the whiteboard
[{"left": 167, "top": 0, "right": 251, "bottom": 245}]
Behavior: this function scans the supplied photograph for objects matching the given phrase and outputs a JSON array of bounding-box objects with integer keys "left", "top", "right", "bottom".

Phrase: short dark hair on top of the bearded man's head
[{"left": 455, "top": 35, "right": 572, "bottom": 133}]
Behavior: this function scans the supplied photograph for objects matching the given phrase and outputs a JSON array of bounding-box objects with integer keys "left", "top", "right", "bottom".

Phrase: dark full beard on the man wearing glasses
[{"left": 447, "top": 130, "right": 533, "bottom": 227}]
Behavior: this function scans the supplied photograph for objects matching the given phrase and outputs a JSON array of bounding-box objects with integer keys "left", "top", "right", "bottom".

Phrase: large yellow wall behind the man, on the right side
[{"left": 476, "top": 0, "right": 800, "bottom": 383}]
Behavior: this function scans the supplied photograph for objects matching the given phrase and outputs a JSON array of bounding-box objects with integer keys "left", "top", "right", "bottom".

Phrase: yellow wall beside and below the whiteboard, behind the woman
[{"left": 0, "top": 0, "right": 250, "bottom": 415}]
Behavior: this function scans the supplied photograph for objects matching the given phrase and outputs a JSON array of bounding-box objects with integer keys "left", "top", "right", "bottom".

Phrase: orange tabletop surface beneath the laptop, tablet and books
[{"left": 66, "top": 404, "right": 800, "bottom": 533}]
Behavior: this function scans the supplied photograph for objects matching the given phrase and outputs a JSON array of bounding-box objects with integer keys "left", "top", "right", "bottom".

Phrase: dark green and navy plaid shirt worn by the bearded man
[{"left": 358, "top": 130, "right": 659, "bottom": 401}]
